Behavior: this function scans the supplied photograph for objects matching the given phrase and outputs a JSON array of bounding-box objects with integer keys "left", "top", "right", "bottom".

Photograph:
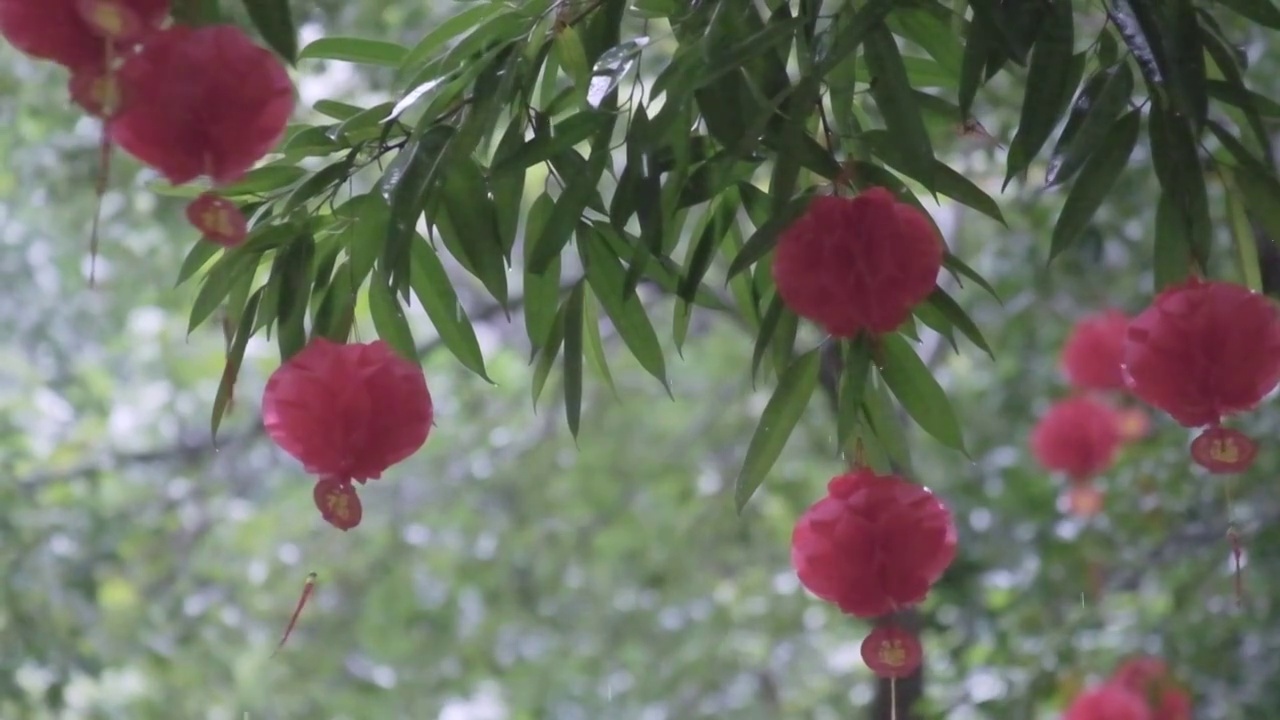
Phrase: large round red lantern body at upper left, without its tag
[{"left": 108, "top": 24, "right": 293, "bottom": 184}]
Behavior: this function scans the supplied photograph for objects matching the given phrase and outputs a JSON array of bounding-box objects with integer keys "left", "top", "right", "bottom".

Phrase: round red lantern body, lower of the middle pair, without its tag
[{"left": 791, "top": 470, "right": 956, "bottom": 618}]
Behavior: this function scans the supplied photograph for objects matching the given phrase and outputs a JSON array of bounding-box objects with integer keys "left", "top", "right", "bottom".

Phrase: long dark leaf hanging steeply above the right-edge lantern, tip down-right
[{"left": 1147, "top": 106, "right": 1212, "bottom": 268}]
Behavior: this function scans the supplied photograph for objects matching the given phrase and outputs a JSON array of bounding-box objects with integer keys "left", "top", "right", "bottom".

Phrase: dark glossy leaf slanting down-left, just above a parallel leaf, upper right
[{"left": 1044, "top": 63, "right": 1133, "bottom": 186}]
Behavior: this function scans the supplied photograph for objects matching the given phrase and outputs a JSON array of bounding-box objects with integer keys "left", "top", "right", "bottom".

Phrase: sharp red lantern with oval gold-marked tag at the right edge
[{"left": 1124, "top": 278, "right": 1280, "bottom": 473}]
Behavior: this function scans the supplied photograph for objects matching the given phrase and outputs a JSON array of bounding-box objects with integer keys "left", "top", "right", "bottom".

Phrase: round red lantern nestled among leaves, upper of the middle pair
[{"left": 773, "top": 187, "right": 945, "bottom": 337}]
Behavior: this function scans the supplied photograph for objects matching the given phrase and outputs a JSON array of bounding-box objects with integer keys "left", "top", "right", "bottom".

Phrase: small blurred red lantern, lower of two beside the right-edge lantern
[{"left": 1030, "top": 397, "right": 1120, "bottom": 480}]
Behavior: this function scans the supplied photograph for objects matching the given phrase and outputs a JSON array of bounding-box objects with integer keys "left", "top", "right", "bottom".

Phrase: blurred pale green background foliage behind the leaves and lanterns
[{"left": 0, "top": 0, "right": 1280, "bottom": 720}]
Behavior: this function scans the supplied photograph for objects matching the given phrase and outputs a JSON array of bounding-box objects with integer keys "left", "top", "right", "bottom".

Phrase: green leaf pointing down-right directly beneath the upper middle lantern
[{"left": 879, "top": 330, "right": 962, "bottom": 452}]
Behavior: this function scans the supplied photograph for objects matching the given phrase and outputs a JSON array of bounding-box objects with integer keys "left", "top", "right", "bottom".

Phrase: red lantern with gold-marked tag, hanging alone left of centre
[{"left": 262, "top": 337, "right": 433, "bottom": 529}]
